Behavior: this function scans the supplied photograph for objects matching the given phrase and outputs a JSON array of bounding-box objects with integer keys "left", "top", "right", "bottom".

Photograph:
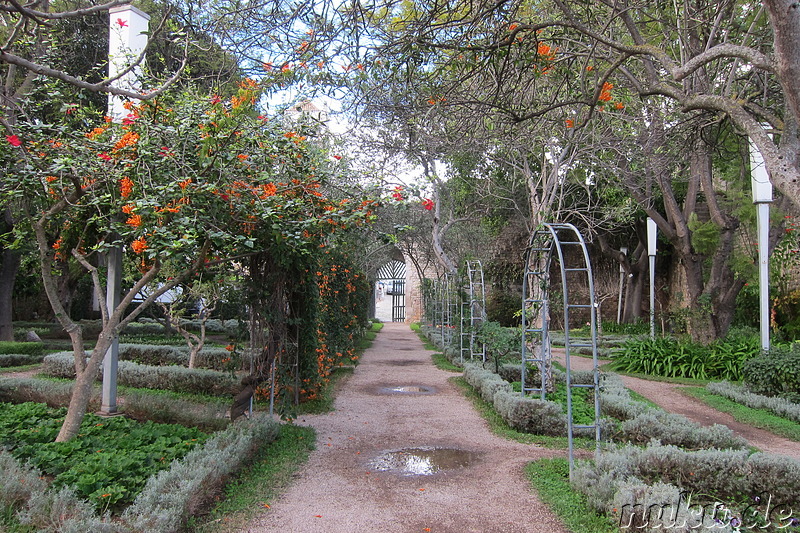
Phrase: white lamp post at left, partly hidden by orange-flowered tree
[{"left": 100, "top": 5, "right": 150, "bottom": 416}]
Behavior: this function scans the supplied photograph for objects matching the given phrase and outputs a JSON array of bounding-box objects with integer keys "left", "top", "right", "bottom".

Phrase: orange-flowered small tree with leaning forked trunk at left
[{"left": 2, "top": 80, "right": 371, "bottom": 440}]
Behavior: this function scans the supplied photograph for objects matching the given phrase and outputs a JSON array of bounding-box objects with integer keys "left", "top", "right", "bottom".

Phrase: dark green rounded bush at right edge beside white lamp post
[{"left": 742, "top": 343, "right": 800, "bottom": 403}]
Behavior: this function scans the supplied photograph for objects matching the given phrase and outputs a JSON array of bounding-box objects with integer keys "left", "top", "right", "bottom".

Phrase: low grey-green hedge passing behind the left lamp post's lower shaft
[{"left": 42, "top": 352, "right": 240, "bottom": 396}]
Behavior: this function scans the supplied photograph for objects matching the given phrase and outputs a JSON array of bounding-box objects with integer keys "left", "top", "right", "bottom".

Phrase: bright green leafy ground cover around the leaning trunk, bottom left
[{"left": 0, "top": 403, "right": 206, "bottom": 510}]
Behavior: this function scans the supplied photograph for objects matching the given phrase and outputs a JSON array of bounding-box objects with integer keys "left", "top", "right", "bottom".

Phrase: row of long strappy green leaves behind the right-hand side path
[{"left": 612, "top": 335, "right": 760, "bottom": 381}]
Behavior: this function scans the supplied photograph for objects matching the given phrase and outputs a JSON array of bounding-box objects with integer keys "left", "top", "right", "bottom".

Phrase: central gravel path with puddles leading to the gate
[{"left": 245, "top": 323, "right": 566, "bottom": 533}]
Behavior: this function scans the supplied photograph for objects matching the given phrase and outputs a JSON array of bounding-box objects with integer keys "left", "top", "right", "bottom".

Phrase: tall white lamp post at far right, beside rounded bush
[{"left": 750, "top": 133, "right": 772, "bottom": 351}]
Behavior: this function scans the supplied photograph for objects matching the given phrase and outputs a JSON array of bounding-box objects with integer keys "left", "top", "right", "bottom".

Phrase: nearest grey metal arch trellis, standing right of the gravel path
[{"left": 522, "top": 223, "right": 600, "bottom": 477}]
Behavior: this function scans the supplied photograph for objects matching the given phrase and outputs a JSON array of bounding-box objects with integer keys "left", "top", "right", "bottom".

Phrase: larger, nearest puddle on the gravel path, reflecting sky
[{"left": 370, "top": 446, "right": 480, "bottom": 476}]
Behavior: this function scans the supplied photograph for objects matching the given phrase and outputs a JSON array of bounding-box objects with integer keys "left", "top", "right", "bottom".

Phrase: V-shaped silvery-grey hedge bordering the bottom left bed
[{"left": 0, "top": 416, "right": 280, "bottom": 533}]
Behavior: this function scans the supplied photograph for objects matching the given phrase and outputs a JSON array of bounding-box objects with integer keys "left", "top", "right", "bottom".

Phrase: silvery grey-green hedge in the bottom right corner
[{"left": 572, "top": 443, "right": 800, "bottom": 532}]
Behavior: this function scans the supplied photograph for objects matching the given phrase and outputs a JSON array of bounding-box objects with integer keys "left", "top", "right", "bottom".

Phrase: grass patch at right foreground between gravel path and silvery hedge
[{"left": 525, "top": 458, "right": 619, "bottom": 533}]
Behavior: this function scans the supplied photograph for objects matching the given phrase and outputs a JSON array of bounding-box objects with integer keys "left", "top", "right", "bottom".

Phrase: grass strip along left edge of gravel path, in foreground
[{"left": 190, "top": 424, "right": 316, "bottom": 533}]
